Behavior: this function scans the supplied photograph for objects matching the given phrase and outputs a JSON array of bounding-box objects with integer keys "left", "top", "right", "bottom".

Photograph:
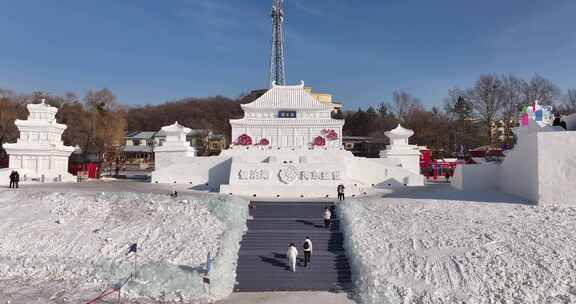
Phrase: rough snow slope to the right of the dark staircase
[{"left": 339, "top": 185, "right": 576, "bottom": 304}]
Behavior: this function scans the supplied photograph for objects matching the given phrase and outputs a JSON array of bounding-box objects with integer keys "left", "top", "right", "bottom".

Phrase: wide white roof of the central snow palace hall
[{"left": 242, "top": 81, "right": 332, "bottom": 110}]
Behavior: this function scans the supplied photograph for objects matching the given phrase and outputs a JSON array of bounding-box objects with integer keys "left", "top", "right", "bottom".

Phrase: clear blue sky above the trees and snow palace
[{"left": 0, "top": 0, "right": 576, "bottom": 109}]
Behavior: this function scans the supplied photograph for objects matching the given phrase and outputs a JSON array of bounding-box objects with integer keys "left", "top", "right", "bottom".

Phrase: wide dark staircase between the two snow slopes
[{"left": 235, "top": 202, "right": 352, "bottom": 292}]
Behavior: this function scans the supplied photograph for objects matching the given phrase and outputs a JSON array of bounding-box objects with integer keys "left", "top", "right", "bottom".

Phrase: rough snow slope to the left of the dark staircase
[{"left": 0, "top": 190, "right": 248, "bottom": 303}]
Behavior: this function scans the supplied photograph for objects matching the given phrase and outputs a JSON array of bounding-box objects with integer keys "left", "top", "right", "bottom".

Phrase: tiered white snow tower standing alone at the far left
[{"left": 0, "top": 99, "right": 76, "bottom": 182}]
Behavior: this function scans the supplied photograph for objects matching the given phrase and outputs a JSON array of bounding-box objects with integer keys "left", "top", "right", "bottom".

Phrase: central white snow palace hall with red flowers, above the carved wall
[{"left": 230, "top": 83, "right": 344, "bottom": 150}]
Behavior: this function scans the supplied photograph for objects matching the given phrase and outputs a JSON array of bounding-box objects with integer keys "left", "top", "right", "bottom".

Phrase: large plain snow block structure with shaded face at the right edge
[{"left": 452, "top": 121, "right": 576, "bottom": 205}]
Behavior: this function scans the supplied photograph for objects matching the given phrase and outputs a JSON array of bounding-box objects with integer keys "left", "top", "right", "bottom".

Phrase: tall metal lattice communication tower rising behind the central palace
[{"left": 268, "top": 0, "right": 286, "bottom": 87}]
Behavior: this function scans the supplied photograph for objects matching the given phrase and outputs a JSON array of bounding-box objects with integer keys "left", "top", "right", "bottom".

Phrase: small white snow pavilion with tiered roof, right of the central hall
[{"left": 380, "top": 124, "right": 420, "bottom": 175}]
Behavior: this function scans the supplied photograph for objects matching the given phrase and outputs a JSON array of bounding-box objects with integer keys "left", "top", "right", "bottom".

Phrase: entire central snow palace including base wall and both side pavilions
[{"left": 152, "top": 83, "right": 424, "bottom": 198}]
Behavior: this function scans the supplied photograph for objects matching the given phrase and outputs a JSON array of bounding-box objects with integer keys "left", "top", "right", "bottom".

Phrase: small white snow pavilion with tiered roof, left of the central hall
[{"left": 154, "top": 122, "right": 196, "bottom": 169}]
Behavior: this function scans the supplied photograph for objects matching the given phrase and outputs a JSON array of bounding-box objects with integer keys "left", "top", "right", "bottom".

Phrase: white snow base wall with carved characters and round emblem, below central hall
[{"left": 152, "top": 144, "right": 424, "bottom": 199}]
